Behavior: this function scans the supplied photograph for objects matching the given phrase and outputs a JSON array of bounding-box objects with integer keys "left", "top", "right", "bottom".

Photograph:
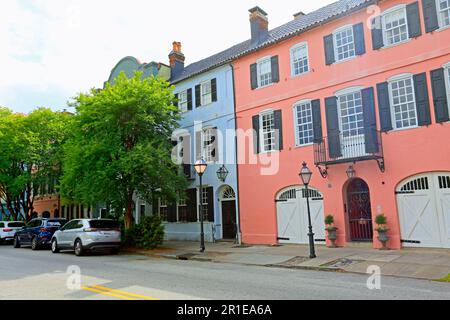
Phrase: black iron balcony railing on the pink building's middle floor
[{"left": 314, "top": 128, "right": 384, "bottom": 170}]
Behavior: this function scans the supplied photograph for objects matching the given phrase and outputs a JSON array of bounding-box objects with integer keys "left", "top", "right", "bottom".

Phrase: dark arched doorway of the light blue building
[{"left": 220, "top": 186, "right": 237, "bottom": 240}]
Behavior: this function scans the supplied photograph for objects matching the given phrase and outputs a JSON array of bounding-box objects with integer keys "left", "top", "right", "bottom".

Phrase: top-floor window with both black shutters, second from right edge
[{"left": 372, "top": 2, "right": 422, "bottom": 50}]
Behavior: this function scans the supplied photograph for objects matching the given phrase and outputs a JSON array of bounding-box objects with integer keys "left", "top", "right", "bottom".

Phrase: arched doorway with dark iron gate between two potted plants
[{"left": 346, "top": 178, "right": 373, "bottom": 241}]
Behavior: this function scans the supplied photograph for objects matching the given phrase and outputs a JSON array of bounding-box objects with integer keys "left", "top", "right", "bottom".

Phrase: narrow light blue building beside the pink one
[{"left": 161, "top": 42, "right": 240, "bottom": 242}]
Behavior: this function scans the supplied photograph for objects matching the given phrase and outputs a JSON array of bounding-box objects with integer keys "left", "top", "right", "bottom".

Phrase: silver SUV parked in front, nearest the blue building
[{"left": 51, "top": 219, "right": 121, "bottom": 256}]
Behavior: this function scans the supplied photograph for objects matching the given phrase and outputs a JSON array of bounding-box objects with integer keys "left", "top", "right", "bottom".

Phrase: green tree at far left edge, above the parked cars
[{"left": 0, "top": 108, "right": 70, "bottom": 219}]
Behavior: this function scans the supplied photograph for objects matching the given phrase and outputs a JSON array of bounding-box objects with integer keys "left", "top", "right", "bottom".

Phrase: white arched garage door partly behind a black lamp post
[{"left": 277, "top": 187, "right": 325, "bottom": 244}]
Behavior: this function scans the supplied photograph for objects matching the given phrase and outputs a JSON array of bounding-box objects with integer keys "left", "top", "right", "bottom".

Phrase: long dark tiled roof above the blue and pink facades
[{"left": 171, "top": 0, "right": 377, "bottom": 83}]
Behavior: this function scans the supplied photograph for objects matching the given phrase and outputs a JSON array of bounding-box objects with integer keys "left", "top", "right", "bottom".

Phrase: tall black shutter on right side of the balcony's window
[{"left": 361, "top": 87, "right": 379, "bottom": 153}]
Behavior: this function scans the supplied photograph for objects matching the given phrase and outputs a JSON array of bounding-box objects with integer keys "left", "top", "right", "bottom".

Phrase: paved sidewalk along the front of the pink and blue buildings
[{"left": 125, "top": 242, "right": 450, "bottom": 280}]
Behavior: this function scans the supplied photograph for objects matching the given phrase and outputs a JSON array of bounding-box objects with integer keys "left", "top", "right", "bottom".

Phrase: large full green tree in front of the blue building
[{"left": 61, "top": 73, "right": 186, "bottom": 229}]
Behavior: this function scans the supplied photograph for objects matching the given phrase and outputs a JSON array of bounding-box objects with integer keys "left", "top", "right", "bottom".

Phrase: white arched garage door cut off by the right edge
[{"left": 397, "top": 173, "right": 450, "bottom": 248}]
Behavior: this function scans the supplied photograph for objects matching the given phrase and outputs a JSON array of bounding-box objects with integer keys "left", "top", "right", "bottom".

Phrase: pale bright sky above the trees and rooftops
[{"left": 0, "top": 0, "right": 334, "bottom": 113}]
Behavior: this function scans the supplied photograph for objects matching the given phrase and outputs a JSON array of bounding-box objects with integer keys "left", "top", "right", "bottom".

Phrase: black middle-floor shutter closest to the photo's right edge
[{"left": 431, "top": 68, "right": 450, "bottom": 123}]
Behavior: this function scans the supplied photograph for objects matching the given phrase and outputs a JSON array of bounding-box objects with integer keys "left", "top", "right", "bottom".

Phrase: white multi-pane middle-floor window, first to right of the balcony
[{"left": 389, "top": 77, "right": 418, "bottom": 129}]
